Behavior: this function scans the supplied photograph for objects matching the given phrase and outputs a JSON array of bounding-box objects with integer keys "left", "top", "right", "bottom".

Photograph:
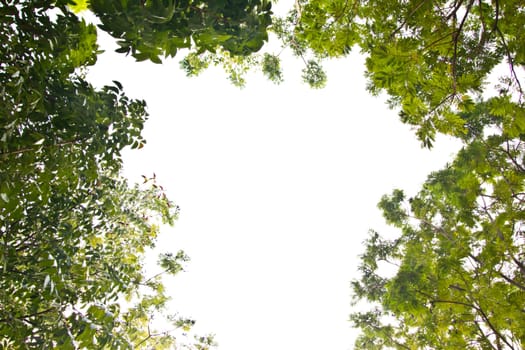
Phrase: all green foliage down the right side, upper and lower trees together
[{"left": 324, "top": 0, "right": 525, "bottom": 349}]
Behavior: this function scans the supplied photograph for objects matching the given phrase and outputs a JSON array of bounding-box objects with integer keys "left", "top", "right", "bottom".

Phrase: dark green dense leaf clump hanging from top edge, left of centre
[{"left": 89, "top": 0, "right": 271, "bottom": 63}]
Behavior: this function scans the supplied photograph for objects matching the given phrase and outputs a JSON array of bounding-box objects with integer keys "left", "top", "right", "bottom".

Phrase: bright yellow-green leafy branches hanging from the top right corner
[{"left": 273, "top": 0, "right": 525, "bottom": 147}]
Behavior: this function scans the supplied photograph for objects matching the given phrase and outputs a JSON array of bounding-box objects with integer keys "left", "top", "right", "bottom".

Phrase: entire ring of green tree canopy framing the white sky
[{"left": 0, "top": 0, "right": 525, "bottom": 350}]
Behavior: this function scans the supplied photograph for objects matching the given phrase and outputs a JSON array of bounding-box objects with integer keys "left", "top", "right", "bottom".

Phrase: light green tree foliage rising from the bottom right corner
[{"left": 351, "top": 111, "right": 525, "bottom": 349}]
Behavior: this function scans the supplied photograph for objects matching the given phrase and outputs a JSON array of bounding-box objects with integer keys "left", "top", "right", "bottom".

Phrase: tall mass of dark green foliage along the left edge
[{"left": 0, "top": 0, "right": 214, "bottom": 349}]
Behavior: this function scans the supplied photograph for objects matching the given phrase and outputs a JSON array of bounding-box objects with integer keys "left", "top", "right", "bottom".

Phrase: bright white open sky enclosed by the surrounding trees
[{"left": 90, "top": 19, "right": 460, "bottom": 350}]
